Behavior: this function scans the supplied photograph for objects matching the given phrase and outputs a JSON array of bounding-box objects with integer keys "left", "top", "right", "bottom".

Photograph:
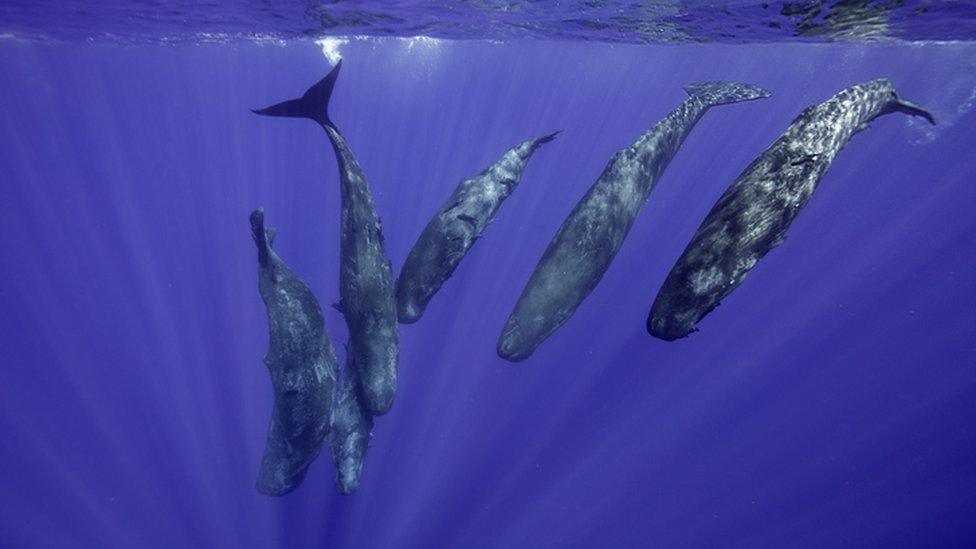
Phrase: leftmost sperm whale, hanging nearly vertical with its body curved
[{"left": 251, "top": 209, "right": 338, "bottom": 496}]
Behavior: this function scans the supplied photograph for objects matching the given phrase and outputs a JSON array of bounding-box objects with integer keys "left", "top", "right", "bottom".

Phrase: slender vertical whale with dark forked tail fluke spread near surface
[{"left": 254, "top": 61, "right": 400, "bottom": 415}]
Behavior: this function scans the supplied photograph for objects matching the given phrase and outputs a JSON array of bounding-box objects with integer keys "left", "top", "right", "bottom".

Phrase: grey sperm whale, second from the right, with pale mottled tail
[{"left": 498, "top": 82, "right": 769, "bottom": 361}]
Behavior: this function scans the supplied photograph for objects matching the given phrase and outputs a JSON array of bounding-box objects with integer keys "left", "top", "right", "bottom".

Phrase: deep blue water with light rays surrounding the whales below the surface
[{"left": 0, "top": 12, "right": 976, "bottom": 548}]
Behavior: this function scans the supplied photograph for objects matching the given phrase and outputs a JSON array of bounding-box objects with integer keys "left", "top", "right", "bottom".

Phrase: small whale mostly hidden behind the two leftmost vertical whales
[{"left": 329, "top": 348, "right": 373, "bottom": 494}]
